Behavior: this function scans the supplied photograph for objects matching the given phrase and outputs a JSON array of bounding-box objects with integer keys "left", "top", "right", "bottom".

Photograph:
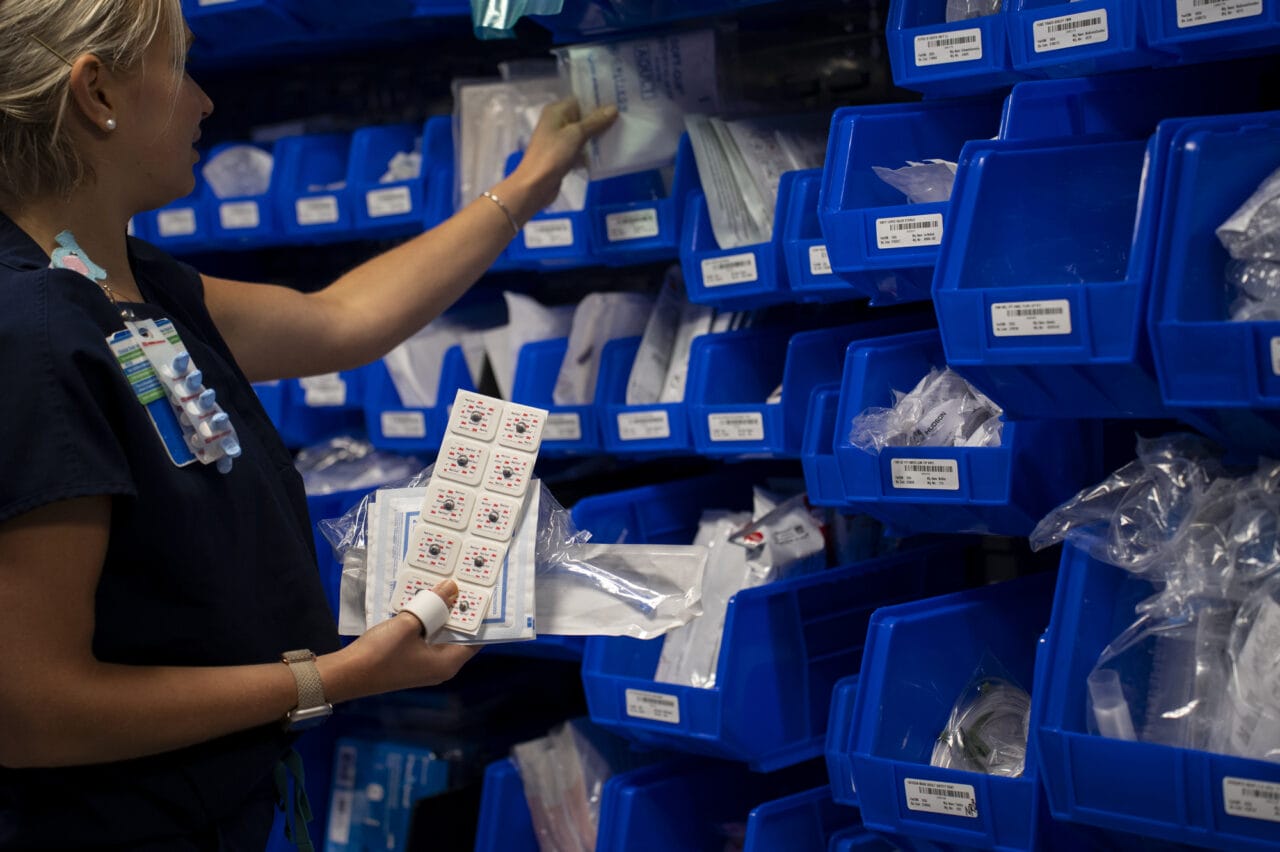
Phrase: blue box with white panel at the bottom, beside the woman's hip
[{"left": 324, "top": 737, "right": 449, "bottom": 852}]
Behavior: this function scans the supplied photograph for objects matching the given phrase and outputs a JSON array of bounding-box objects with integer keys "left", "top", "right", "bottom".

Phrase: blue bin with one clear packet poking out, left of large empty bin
[{"left": 818, "top": 97, "right": 1002, "bottom": 304}]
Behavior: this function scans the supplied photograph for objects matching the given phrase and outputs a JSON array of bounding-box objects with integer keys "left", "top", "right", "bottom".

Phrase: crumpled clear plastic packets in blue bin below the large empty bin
[{"left": 849, "top": 367, "right": 1002, "bottom": 453}]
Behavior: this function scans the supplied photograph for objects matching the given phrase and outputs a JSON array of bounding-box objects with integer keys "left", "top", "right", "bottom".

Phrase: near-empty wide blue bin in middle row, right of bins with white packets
[{"left": 685, "top": 316, "right": 932, "bottom": 458}]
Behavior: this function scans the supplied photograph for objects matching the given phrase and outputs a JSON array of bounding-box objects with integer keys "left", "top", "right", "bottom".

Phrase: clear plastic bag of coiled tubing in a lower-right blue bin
[{"left": 929, "top": 660, "right": 1032, "bottom": 778}]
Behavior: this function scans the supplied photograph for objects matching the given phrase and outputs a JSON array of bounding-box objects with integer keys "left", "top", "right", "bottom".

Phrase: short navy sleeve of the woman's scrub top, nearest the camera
[{"left": 0, "top": 270, "right": 136, "bottom": 522}]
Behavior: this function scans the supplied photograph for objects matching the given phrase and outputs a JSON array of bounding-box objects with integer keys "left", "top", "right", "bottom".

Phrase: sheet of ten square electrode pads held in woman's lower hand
[{"left": 392, "top": 390, "right": 547, "bottom": 638}]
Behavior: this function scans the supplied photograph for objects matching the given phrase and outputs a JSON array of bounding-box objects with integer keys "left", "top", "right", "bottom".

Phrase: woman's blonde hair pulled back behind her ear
[{"left": 0, "top": 0, "right": 187, "bottom": 201}]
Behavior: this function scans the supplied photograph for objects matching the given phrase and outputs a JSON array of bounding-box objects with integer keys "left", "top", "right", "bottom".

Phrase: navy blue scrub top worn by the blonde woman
[{"left": 0, "top": 214, "right": 338, "bottom": 849}]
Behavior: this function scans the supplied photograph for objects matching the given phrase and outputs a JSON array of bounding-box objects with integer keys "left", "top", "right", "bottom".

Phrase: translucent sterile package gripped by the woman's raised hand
[{"left": 557, "top": 29, "right": 722, "bottom": 180}]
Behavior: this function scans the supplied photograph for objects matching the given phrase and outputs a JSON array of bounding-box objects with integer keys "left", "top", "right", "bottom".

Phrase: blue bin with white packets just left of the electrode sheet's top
[{"left": 365, "top": 347, "right": 475, "bottom": 453}]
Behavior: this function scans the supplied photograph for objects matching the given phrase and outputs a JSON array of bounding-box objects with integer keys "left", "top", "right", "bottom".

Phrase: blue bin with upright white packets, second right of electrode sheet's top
[{"left": 595, "top": 335, "right": 707, "bottom": 455}]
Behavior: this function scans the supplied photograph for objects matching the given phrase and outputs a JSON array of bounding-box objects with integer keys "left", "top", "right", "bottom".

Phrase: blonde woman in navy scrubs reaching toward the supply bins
[{"left": 0, "top": 0, "right": 613, "bottom": 849}]
